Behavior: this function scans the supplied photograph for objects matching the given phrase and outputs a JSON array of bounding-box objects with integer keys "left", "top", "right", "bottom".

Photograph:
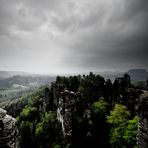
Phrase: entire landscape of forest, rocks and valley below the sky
[{"left": 0, "top": 69, "right": 148, "bottom": 148}]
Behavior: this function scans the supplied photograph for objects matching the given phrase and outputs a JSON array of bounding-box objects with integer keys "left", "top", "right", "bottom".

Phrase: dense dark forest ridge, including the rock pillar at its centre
[{"left": 2, "top": 72, "right": 148, "bottom": 148}]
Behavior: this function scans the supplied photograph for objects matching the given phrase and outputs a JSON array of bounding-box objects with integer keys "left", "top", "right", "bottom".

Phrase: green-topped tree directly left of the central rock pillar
[{"left": 35, "top": 112, "right": 62, "bottom": 148}]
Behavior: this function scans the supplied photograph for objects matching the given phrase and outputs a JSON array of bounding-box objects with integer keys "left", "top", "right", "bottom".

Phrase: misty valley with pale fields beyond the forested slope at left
[{"left": 0, "top": 72, "right": 55, "bottom": 102}]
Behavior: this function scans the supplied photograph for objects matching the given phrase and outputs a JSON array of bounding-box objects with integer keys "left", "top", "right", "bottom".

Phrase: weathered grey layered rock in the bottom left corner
[{"left": 0, "top": 108, "right": 18, "bottom": 148}]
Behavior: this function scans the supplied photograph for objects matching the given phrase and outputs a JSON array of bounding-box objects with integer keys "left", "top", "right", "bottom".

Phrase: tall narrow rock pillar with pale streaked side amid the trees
[{"left": 57, "top": 90, "right": 78, "bottom": 144}]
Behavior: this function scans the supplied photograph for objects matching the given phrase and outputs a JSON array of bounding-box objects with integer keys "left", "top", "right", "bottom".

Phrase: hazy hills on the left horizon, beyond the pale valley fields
[{"left": 0, "top": 71, "right": 56, "bottom": 89}]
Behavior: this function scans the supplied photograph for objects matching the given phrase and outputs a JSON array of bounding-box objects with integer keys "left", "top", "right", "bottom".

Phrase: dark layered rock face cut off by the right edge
[{"left": 137, "top": 92, "right": 148, "bottom": 148}]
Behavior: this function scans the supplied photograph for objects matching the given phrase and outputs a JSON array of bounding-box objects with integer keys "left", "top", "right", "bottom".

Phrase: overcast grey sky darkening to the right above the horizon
[{"left": 0, "top": 0, "right": 148, "bottom": 74}]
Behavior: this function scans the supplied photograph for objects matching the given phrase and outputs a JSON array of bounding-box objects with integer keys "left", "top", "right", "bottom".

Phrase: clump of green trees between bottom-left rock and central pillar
[{"left": 18, "top": 107, "right": 61, "bottom": 148}]
